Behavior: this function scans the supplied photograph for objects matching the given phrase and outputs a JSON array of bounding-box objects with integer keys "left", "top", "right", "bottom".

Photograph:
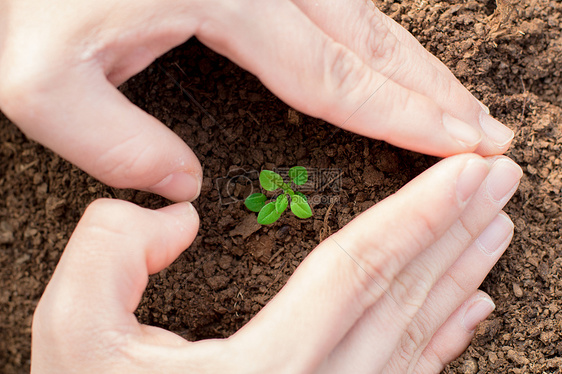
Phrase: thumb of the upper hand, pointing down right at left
[{"left": 1, "top": 65, "right": 202, "bottom": 201}]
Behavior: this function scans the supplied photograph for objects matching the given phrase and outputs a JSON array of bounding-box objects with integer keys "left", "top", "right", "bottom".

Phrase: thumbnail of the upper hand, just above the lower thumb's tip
[{"left": 147, "top": 171, "right": 201, "bottom": 201}]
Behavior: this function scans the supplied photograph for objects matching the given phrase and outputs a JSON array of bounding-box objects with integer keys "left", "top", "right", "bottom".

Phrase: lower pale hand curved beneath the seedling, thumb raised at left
[{"left": 32, "top": 155, "right": 522, "bottom": 374}]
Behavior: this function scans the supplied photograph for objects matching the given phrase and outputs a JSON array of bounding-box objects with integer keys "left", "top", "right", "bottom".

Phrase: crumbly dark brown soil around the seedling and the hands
[{"left": 0, "top": 0, "right": 562, "bottom": 374}]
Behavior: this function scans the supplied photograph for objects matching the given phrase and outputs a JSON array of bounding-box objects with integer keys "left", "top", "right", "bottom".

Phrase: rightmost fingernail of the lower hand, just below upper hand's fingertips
[{"left": 486, "top": 158, "right": 523, "bottom": 203}]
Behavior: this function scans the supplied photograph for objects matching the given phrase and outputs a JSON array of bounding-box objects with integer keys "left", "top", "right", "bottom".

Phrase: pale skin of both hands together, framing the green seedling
[{"left": 0, "top": 0, "right": 521, "bottom": 373}]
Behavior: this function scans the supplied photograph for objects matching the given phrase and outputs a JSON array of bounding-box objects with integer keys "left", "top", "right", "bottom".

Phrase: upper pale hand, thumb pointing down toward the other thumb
[{"left": 0, "top": 0, "right": 513, "bottom": 201}]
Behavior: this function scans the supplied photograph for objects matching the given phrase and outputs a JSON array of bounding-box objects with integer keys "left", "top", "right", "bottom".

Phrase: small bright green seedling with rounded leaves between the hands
[{"left": 244, "top": 166, "right": 312, "bottom": 225}]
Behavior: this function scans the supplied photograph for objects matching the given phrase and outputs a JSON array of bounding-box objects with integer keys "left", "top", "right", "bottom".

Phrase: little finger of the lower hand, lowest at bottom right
[{"left": 413, "top": 291, "right": 495, "bottom": 373}]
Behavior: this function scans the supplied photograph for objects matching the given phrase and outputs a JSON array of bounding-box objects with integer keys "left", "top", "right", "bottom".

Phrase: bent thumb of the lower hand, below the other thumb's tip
[{"left": 53, "top": 200, "right": 199, "bottom": 314}]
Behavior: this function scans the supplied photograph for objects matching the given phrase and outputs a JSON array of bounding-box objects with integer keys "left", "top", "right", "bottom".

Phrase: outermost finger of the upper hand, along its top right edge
[{"left": 293, "top": 0, "right": 513, "bottom": 155}]
